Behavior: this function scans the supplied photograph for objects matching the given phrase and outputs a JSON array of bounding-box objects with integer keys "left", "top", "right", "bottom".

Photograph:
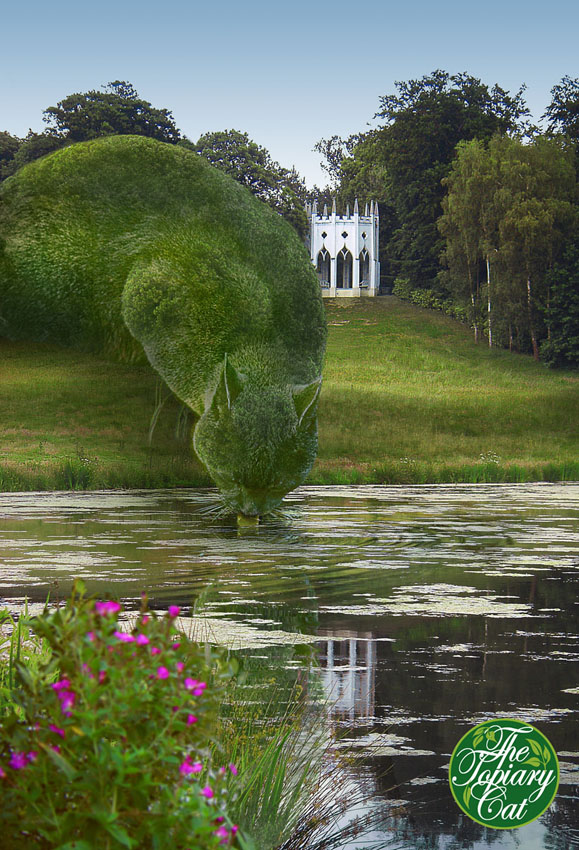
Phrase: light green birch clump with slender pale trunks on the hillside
[{"left": 439, "top": 135, "right": 575, "bottom": 359}]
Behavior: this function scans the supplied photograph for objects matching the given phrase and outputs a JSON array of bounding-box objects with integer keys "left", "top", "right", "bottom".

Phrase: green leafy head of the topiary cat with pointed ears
[{"left": 193, "top": 356, "right": 321, "bottom": 516}]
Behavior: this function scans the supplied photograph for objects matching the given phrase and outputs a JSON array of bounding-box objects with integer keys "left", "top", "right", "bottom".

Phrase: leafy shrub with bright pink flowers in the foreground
[{"left": 0, "top": 587, "right": 249, "bottom": 850}]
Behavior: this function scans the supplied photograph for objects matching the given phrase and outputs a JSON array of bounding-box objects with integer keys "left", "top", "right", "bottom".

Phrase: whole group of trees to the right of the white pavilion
[{"left": 316, "top": 70, "right": 579, "bottom": 368}]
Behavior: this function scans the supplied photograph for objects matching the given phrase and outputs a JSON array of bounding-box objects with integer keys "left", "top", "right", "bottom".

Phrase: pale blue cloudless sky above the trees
[{"left": 0, "top": 0, "right": 579, "bottom": 186}]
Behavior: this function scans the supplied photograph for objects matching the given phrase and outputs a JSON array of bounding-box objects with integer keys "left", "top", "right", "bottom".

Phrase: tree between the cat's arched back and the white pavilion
[{"left": 189, "top": 130, "right": 307, "bottom": 238}]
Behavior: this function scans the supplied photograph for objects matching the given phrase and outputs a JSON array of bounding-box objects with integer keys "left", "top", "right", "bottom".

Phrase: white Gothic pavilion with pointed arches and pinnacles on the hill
[{"left": 306, "top": 199, "right": 380, "bottom": 296}]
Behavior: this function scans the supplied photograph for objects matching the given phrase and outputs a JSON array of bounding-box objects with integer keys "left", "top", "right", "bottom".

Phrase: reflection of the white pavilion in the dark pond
[{"left": 319, "top": 637, "right": 376, "bottom": 718}]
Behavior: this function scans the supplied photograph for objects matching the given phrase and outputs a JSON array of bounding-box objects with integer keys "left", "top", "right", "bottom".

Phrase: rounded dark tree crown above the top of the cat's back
[{"left": 44, "top": 80, "right": 180, "bottom": 144}]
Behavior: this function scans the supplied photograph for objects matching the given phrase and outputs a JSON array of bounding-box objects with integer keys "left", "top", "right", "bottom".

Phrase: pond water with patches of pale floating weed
[{"left": 0, "top": 484, "right": 579, "bottom": 850}]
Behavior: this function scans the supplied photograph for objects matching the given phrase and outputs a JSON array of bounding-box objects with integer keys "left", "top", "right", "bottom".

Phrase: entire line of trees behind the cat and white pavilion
[{"left": 0, "top": 70, "right": 579, "bottom": 368}]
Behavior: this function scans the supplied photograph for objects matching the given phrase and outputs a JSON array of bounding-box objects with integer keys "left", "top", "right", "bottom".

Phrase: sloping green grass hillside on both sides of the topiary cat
[{"left": 0, "top": 297, "right": 579, "bottom": 490}]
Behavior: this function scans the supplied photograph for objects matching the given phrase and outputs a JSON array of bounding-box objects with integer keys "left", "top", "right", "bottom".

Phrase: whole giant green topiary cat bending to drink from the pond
[{"left": 0, "top": 136, "right": 326, "bottom": 516}]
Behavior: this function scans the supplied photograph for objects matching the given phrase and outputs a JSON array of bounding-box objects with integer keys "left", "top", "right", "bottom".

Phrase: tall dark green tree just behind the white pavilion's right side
[{"left": 322, "top": 70, "right": 528, "bottom": 287}]
